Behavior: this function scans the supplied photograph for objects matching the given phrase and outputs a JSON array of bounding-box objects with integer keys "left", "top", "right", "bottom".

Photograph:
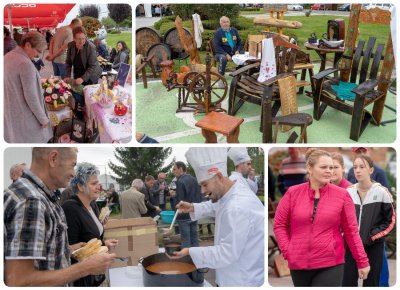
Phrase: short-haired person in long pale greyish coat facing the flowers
[{"left": 4, "top": 31, "right": 53, "bottom": 143}]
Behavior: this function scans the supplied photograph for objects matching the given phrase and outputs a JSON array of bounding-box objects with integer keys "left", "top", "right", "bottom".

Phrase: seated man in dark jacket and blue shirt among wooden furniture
[{"left": 214, "top": 16, "right": 243, "bottom": 85}]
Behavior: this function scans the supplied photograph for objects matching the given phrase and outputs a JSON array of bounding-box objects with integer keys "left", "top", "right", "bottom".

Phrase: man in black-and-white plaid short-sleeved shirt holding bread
[{"left": 4, "top": 147, "right": 115, "bottom": 286}]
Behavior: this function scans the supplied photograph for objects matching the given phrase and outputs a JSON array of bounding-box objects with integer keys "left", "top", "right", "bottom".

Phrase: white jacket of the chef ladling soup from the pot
[{"left": 189, "top": 182, "right": 264, "bottom": 287}]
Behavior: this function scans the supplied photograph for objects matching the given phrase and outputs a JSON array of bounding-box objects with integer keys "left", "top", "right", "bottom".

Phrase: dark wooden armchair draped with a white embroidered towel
[{"left": 228, "top": 35, "right": 299, "bottom": 116}]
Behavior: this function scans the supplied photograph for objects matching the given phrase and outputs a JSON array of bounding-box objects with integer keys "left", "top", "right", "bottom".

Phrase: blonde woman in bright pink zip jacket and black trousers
[{"left": 274, "top": 149, "right": 370, "bottom": 287}]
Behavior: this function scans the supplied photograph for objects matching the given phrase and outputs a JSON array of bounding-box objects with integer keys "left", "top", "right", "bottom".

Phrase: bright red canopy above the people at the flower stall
[{"left": 4, "top": 3, "right": 75, "bottom": 27}]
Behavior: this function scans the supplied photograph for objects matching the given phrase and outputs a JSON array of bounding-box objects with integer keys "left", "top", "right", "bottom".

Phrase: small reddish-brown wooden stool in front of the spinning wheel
[{"left": 195, "top": 111, "right": 244, "bottom": 143}]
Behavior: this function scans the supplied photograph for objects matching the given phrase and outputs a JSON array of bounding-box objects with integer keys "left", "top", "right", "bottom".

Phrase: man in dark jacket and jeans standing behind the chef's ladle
[{"left": 172, "top": 161, "right": 202, "bottom": 248}]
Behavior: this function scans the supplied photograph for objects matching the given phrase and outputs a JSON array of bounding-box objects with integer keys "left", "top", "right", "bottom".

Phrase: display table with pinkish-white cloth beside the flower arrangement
[{"left": 83, "top": 84, "right": 132, "bottom": 143}]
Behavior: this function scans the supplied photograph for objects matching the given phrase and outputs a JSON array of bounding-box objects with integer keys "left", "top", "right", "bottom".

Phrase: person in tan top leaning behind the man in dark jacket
[{"left": 46, "top": 18, "right": 82, "bottom": 78}]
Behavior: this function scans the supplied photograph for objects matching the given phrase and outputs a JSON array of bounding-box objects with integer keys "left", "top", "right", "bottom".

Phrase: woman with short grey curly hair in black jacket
[{"left": 62, "top": 162, "right": 118, "bottom": 286}]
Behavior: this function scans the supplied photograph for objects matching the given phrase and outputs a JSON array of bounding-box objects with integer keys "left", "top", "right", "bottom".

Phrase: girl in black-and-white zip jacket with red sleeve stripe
[{"left": 342, "top": 155, "right": 396, "bottom": 287}]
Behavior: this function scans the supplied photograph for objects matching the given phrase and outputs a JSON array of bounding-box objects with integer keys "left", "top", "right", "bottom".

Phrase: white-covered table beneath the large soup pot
[{"left": 107, "top": 265, "right": 212, "bottom": 287}]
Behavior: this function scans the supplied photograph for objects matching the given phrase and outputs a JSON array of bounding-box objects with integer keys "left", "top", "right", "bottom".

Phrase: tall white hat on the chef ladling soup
[{"left": 185, "top": 147, "right": 228, "bottom": 183}]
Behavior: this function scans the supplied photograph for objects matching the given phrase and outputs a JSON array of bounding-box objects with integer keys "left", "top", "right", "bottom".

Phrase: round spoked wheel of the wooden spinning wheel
[{"left": 189, "top": 72, "right": 228, "bottom": 107}]
